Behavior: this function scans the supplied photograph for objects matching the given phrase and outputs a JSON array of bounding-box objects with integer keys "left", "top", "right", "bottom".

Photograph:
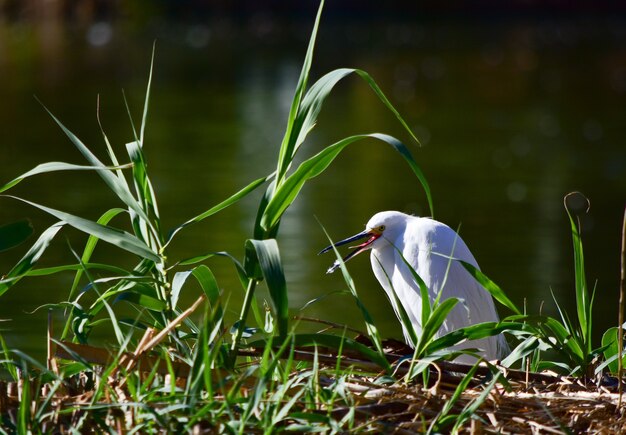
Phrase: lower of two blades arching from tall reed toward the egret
[{"left": 261, "top": 133, "right": 430, "bottom": 230}]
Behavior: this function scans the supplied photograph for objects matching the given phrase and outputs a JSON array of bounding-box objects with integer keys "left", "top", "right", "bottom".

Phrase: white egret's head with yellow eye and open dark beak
[{"left": 320, "top": 211, "right": 409, "bottom": 273}]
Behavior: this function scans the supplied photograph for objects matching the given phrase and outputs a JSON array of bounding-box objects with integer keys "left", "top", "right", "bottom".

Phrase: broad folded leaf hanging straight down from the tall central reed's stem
[{"left": 246, "top": 239, "right": 289, "bottom": 338}]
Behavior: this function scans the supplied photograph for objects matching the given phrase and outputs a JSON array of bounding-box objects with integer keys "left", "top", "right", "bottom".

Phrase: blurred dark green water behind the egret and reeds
[{"left": 0, "top": 0, "right": 626, "bottom": 357}]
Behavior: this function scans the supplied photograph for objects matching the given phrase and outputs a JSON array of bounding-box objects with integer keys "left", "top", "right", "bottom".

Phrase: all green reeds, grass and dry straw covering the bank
[{"left": 0, "top": 2, "right": 626, "bottom": 433}]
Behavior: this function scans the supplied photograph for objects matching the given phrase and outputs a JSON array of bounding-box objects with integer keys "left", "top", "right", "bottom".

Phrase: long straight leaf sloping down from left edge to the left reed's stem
[{"left": 7, "top": 196, "right": 161, "bottom": 263}]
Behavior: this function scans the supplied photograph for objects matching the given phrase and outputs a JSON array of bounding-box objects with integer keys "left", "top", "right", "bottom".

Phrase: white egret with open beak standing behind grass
[{"left": 320, "top": 211, "right": 509, "bottom": 363}]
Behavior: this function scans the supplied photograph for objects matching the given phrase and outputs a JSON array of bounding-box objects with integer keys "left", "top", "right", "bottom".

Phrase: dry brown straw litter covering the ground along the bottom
[{"left": 0, "top": 342, "right": 626, "bottom": 434}]
